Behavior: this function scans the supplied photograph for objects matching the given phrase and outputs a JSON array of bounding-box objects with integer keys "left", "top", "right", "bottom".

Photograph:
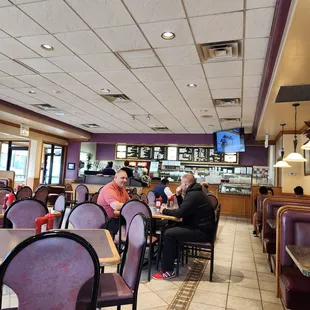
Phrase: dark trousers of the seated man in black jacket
[{"left": 162, "top": 227, "right": 210, "bottom": 271}]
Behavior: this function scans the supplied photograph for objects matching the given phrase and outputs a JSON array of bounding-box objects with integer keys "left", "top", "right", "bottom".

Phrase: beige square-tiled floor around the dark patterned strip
[{"left": 2, "top": 218, "right": 284, "bottom": 310}]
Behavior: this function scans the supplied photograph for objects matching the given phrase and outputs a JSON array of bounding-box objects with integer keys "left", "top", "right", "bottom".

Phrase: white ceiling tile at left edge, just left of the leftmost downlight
[{"left": 0, "top": 38, "right": 38, "bottom": 59}]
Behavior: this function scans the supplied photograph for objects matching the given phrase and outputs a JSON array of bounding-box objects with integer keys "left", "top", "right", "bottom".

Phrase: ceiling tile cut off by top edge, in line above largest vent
[{"left": 184, "top": 0, "right": 242, "bottom": 17}]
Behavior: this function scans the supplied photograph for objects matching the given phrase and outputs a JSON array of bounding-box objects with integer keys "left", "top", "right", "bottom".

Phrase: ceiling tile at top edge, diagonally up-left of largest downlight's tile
[{"left": 67, "top": 0, "right": 134, "bottom": 28}]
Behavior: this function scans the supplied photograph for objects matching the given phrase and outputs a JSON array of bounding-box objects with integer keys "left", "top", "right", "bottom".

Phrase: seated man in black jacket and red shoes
[{"left": 153, "top": 174, "right": 215, "bottom": 279}]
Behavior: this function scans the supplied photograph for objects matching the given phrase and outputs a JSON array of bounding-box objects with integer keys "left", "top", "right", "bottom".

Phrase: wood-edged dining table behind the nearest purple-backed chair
[{"left": 0, "top": 229, "right": 120, "bottom": 267}]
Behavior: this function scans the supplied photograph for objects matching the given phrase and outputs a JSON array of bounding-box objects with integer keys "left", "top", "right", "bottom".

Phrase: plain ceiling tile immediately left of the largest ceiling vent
[{"left": 155, "top": 45, "right": 200, "bottom": 66}]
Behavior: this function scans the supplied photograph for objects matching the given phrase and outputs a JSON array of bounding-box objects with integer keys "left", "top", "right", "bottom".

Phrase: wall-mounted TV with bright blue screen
[{"left": 213, "top": 128, "right": 245, "bottom": 153}]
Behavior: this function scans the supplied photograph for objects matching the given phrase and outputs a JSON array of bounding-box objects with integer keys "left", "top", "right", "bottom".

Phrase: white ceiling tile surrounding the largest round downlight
[{"left": 140, "top": 19, "right": 194, "bottom": 48}]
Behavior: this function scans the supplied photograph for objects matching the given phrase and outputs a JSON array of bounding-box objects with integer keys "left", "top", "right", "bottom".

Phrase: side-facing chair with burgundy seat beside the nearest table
[{"left": 78, "top": 213, "right": 147, "bottom": 310}]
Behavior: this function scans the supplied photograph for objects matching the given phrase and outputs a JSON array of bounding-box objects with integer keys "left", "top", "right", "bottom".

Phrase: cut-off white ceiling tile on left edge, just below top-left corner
[{"left": 0, "top": 6, "right": 46, "bottom": 37}]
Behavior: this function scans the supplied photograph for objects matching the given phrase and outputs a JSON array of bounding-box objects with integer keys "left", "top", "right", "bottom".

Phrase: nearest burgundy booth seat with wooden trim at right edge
[{"left": 277, "top": 206, "right": 310, "bottom": 310}]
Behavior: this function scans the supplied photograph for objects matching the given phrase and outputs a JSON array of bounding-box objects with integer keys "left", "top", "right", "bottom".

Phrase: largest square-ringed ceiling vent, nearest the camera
[{"left": 198, "top": 41, "right": 242, "bottom": 62}]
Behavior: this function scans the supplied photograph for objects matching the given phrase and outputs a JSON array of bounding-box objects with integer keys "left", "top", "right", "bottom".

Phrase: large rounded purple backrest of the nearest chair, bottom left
[{"left": 0, "top": 231, "right": 100, "bottom": 310}]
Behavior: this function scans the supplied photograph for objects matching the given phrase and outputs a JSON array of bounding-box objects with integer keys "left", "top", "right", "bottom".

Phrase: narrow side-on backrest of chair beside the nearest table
[{"left": 120, "top": 213, "right": 147, "bottom": 296}]
